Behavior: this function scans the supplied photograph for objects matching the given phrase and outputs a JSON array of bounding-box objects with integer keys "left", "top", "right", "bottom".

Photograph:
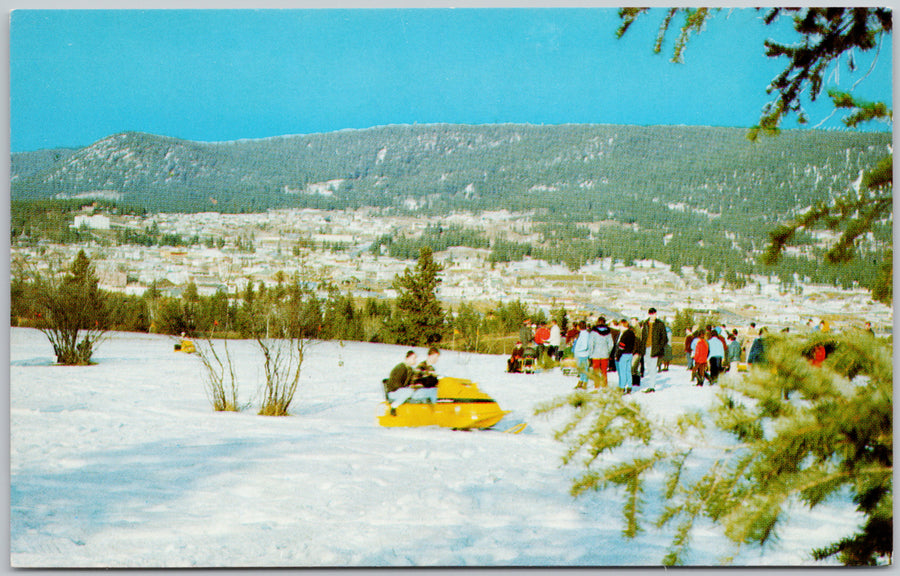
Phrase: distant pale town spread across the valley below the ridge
[{"left": 11, "top": 205, "right": 893, "bottom": 334}]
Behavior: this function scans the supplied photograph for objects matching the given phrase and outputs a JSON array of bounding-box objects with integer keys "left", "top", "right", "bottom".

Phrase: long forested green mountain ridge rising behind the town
[{"left": 11, "top": 124, "right": 892, "bottom": 294}]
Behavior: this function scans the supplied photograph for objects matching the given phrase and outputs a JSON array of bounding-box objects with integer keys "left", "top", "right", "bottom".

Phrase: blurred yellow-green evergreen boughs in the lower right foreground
[{"left": 539, "top": 331, "right": 893, "bottom": 565}]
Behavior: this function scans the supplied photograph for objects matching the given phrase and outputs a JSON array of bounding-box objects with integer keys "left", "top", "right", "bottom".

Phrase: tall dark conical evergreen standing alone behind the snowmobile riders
[{"left": 391, "top": 246, "right": 446, "bottom": 346}]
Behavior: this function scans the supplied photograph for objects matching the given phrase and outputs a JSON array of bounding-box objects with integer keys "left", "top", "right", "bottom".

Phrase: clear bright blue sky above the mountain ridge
[{"left": 10, "top": 8, "right": 892, "bottom": 152}]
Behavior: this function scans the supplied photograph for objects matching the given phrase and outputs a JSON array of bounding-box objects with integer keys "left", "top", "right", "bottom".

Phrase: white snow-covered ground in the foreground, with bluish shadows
[{"left": 10, "top": 328, "right": 859, "bottom": 567}]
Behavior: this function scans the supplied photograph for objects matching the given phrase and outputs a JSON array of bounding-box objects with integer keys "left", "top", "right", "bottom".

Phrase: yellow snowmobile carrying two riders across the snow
[{"left": 378, "top": 377, "right": 525, "bottom": 433}]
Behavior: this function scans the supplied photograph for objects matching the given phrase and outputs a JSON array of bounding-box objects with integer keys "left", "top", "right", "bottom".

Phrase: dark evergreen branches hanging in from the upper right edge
[{"left": 617, "top": 7, "right": 893, "bottom": 303}]
